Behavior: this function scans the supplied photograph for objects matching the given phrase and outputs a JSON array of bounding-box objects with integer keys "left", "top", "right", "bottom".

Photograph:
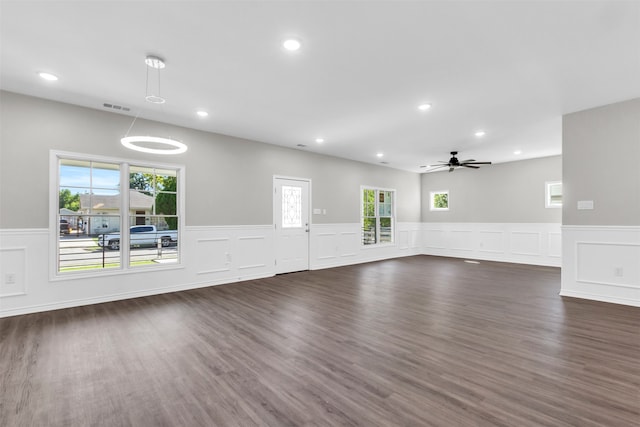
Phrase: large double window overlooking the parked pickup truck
[{"left": 52, "top": 153, "right": 182, "bottom": 274}]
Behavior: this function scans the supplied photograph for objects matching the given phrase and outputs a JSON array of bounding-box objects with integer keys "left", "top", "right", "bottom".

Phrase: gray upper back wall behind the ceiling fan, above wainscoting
[{"left": 421, "top": 156, "right": 562, "bottom": 223}]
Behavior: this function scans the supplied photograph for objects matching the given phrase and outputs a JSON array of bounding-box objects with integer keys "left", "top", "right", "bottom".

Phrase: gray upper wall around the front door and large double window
[{"left": 0, "top": 92, "right": 420, "bottom": 229}]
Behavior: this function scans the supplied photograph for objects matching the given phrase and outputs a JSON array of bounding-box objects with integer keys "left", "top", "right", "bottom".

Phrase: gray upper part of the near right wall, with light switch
[{"left": 562, "top": 98, "right": 640, "bottom": 225}]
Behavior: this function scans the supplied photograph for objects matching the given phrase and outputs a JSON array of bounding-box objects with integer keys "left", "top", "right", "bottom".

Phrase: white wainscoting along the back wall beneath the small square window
[{"left": 422, "top": 222, "right": 561, "bottom": 267}]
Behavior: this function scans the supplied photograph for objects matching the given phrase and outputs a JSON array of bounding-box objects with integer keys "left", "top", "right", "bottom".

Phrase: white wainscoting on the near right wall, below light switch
[{"left": 560, "top": 226, "right": 640, "bottom": 307}]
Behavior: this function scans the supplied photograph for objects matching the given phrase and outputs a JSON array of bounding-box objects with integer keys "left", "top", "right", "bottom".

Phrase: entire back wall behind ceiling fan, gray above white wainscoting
[{"left": 421, "top": 156, "right": 562, "bottom": 267}]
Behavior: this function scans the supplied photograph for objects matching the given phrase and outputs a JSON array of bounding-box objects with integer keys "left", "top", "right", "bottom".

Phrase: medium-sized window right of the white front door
[{"left": 361, "top": 187, "right": 395, "bottom": 245}]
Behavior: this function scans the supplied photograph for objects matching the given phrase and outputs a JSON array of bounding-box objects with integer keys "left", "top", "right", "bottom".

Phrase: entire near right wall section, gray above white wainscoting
[{"left": 560, "top": 98, "right": 640, "bottom": 306}]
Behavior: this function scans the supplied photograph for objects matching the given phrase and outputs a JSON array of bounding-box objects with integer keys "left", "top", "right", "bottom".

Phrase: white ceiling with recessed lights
[{"left": 0, "top": 0, "right": 640, "bottom": 172}]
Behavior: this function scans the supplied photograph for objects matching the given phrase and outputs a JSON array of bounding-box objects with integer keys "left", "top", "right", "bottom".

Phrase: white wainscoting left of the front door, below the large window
[{"left": 0, "top": 225, "right": 275, "bottom": 317}]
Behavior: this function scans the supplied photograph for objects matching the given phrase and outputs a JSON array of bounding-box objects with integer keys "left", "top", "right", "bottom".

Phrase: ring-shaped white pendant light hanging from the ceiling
[{"left": 120, "top": 56, "right": 187, "bottom": 154}]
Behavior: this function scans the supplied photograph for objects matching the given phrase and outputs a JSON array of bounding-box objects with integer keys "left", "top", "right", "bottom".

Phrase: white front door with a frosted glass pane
[{"left": 273, "top": 178, "right": 309, "bottom": 274}]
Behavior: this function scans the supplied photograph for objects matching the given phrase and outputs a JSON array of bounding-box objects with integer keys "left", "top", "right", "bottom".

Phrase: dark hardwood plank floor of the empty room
[{"left": 0, "top": 256, "right": 640, "bottom": 427}]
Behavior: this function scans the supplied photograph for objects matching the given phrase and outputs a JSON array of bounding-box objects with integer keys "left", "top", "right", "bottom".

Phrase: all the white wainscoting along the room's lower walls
[{"left": 8, "top": 222, "right": 608, "bottom": 317}]
